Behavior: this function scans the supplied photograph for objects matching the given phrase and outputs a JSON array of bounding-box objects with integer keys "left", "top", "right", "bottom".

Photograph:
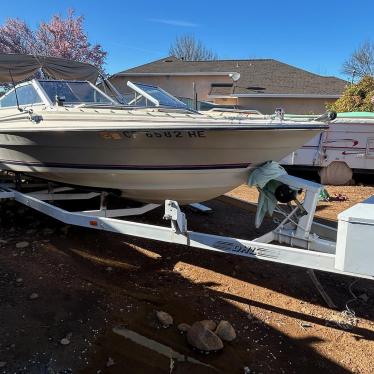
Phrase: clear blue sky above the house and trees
[{"left": 0, "top": 0, "right": 374, "bottom": 76}]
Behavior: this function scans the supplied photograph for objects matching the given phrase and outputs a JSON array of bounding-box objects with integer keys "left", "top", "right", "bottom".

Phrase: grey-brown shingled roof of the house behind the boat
[{"left": 115, "top": 56, "right": 347, "bottom": 97}]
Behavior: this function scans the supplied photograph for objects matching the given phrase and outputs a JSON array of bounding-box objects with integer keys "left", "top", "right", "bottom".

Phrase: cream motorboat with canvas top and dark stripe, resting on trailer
[{"left": 0, "top": 55, "right": 327, "bottom": 204}]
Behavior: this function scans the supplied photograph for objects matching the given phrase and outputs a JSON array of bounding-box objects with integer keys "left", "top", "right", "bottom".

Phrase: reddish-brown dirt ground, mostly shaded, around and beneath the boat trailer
[{"left": 0, "top": 187, "right": 374, "bottom": 374}]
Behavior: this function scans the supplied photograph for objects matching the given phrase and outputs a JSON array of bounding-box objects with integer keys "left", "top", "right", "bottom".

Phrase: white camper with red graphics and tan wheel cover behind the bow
[{"left": 280, "top": 112, "right": 374, "bottom": 185}]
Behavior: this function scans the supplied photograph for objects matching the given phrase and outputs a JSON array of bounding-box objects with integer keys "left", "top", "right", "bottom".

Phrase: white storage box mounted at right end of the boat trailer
[{"left": 335, "top": 196, "right": 374, "bottom": 276}]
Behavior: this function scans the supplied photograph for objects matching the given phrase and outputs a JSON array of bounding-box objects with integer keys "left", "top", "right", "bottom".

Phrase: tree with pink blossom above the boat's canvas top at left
[{"left": 0, "top": 9, "right": 107, "bottom": 70}]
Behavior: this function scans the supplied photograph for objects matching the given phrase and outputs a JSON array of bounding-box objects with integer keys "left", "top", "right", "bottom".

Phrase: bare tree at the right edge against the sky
[{"left": 342, "top": 41, "right": 374, "bottom": 81}]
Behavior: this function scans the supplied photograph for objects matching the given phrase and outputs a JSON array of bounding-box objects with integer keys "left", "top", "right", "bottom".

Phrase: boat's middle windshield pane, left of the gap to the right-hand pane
[{"left": 39, "top": 80, "right": 114, "bottom": 104}]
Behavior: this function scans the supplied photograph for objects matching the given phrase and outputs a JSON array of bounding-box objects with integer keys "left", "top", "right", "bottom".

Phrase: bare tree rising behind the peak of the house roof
[{"left": 169, "top": 35, "right": 217, "bottom": 61}]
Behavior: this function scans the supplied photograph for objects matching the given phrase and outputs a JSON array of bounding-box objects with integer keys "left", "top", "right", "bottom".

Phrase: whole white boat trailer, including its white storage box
[{"left": 0, "top": 175, "right": 374, "bottom": 279}]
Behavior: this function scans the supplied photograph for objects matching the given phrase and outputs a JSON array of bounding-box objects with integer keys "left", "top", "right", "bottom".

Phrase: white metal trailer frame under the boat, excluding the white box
[{"left": 0, "top": 175, "right": 374, "bottom": 279}]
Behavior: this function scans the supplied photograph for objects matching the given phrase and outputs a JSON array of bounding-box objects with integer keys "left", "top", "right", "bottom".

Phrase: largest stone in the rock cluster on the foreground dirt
[{"left": 187, "top": 322, "right": 223, "bottom": 352}]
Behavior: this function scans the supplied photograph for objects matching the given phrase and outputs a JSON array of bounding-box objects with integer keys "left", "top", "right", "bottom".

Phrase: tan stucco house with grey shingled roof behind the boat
[{"left": 110, "top": 56, "right": 347, "bottom": 114}]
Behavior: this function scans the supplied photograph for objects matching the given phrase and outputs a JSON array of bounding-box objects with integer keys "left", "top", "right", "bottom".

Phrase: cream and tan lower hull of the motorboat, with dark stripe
[{"left": 0, "top": 127, "right": 321, "bottom": 204}]
